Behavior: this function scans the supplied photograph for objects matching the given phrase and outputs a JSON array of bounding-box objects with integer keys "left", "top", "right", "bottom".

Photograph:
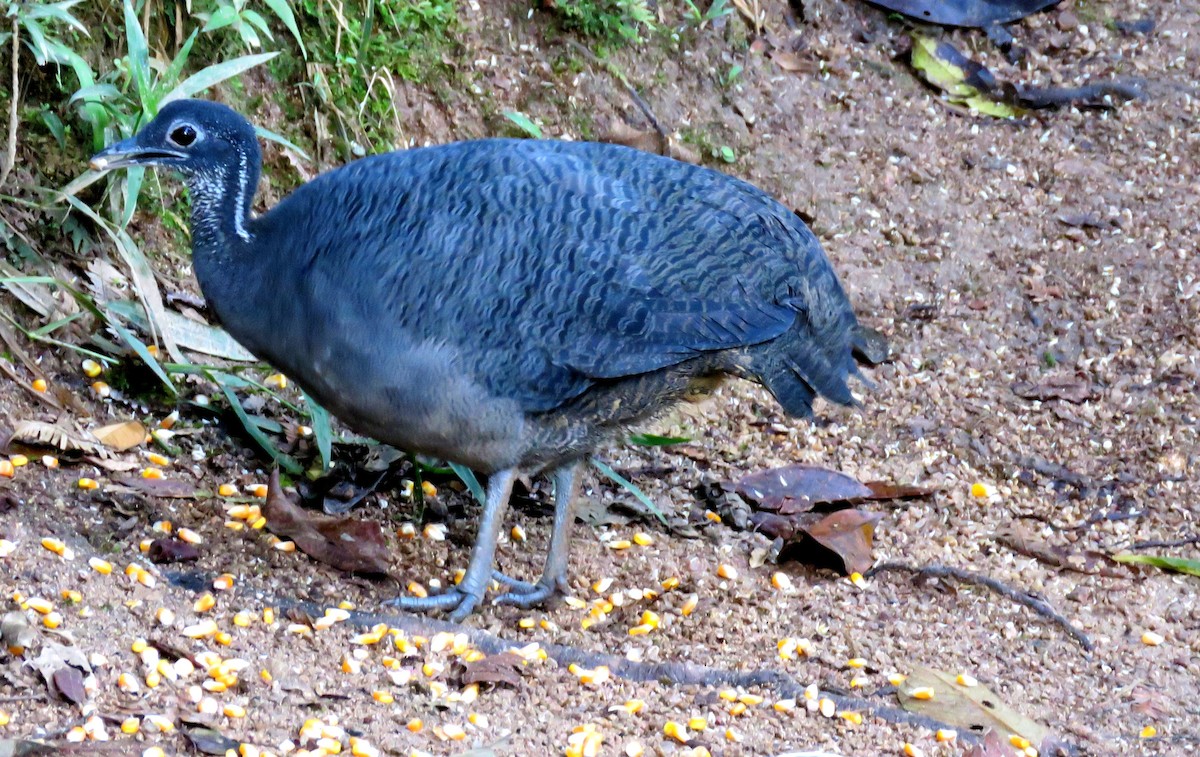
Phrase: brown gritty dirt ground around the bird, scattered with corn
[{"left": 0, "top": 0, "right": 1200, "bottom": 756}]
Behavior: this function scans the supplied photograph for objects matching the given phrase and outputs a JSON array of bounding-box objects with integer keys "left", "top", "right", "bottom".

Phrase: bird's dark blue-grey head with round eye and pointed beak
[{"left": 90, "top": 100, "right": 258, "bottom": 175}]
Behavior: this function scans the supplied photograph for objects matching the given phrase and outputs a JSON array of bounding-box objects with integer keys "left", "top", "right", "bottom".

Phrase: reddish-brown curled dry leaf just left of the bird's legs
[{"left": 263, "top": 470, "right": 391, "bottom": 573}]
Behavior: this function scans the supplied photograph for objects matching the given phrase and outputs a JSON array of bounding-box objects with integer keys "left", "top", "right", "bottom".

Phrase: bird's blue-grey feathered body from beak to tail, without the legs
[{"left": 88, "top": 101, "right": 858, "bottom": 623}]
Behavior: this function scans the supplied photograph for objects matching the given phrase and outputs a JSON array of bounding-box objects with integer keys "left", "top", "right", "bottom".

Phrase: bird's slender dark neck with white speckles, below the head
[{"left": 187, "top": 144, "right": 262, "bottom": 254}]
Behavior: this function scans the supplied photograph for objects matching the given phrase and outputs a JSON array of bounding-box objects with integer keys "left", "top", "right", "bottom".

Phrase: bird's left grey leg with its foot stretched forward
[{"left": 384, "top": 468, "right": 516, "bottom": 623}]
